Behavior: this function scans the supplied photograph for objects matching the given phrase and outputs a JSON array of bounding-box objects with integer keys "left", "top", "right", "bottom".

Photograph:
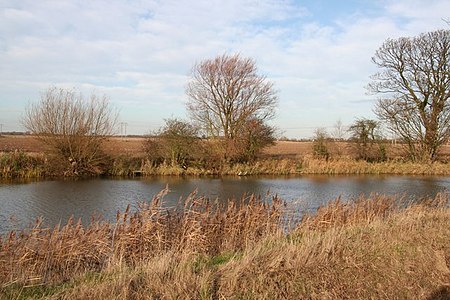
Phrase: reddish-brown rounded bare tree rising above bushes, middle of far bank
[{"left": 186, "top": 54, "right": 278, "bottom": 159}]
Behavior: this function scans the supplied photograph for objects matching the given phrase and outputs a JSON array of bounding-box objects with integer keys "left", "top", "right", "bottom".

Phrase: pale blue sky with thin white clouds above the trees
[{"left": 0, "top": 0, "right": 450, "bottom": 138}]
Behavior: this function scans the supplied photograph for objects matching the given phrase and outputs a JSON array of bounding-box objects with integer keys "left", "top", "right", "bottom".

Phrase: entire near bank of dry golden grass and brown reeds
[{"left": 0, "top": 192, "right": 450, "bottom": 299}]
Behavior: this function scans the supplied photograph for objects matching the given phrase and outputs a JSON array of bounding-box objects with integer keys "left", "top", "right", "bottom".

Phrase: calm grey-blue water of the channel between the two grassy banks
[{"left": 0, "top": 176, "right": 450, "bottom": 234}]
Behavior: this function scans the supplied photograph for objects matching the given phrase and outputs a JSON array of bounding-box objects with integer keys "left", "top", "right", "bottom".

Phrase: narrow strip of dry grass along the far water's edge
[{"left": 0, "top": 151, "right": 450, "bottom": 178}]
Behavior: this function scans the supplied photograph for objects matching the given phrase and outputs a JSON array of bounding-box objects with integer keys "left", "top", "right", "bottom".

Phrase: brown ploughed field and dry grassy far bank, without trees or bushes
[{"left": 0, "top": 135, "right": 450, "bottom": 178}]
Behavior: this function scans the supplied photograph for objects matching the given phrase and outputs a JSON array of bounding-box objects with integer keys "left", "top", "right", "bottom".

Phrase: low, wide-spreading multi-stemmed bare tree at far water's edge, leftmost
[{"left": 22, "top": 87, "right": 117, "bottom": 175}]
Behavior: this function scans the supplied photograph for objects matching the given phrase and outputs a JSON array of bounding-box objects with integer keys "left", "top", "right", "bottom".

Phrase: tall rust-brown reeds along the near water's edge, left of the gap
[{"left": 0, "top": 189, "right": 282, "bottom": 286}]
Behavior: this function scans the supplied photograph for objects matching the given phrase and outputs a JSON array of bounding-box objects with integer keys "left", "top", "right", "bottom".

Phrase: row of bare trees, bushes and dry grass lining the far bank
[{"left": 0, "top": 30, "right": 450, "bottom": 177}]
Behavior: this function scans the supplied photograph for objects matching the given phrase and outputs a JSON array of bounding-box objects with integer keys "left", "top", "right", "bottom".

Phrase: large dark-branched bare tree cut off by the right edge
[{"left": 369, "top": 30, "right": 450, "bottom": 161}]
